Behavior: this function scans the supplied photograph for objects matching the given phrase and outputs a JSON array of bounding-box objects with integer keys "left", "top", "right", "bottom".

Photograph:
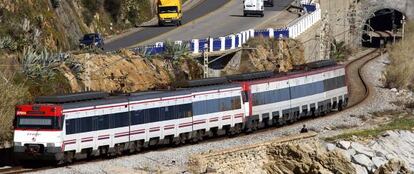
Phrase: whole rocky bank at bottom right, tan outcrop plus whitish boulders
[{"left": 189, "top": 131, "right": 414, "bottom": 174}]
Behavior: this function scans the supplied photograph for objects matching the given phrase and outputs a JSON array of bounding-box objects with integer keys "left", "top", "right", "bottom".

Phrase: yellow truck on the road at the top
[{"left": 158, "top": 0, "right": 183, "bottom": 26}]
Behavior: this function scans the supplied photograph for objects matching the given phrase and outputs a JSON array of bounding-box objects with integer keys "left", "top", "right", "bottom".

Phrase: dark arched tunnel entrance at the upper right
[{"left": 362, "top": 9, "right": 404, "bottom": 47}]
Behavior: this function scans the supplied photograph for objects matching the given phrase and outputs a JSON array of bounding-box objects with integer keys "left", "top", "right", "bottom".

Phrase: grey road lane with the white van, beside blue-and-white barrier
[{"left": 139, "top": 0, "right": 293, "bottom": 45}]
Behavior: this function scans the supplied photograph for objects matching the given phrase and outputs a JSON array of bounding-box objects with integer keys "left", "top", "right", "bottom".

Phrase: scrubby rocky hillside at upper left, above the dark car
[{"left": 0, "top": 0, "right": 155, "bottom": 51}]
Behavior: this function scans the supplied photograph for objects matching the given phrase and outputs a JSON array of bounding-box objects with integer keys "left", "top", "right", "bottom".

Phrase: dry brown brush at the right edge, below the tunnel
[{"left": 385, "top": 23, "right": 414, "bottom": 90}]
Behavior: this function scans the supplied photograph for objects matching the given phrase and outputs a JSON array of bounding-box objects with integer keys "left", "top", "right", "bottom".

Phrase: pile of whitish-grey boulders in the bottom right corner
[{"left": 327, "top": 131, "right": 414, "bottom": 174}]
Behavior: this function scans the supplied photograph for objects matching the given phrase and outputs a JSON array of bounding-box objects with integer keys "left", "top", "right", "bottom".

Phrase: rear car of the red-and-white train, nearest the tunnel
[{"left": 246, "top": 61, "right": 348, "bottom": 129}]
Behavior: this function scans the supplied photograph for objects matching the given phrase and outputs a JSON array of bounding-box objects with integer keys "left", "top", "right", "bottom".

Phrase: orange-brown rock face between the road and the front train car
[{"left": 67, "top": 50, "right": 201, "bottom": 92}]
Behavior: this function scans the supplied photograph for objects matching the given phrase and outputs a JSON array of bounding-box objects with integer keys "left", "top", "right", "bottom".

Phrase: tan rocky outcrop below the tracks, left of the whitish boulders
[{"left": 190, "top": 137, "right": 355, "bottom": 174}]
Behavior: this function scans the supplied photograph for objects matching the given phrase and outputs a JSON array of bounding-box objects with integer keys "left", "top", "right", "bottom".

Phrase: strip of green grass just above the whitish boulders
[{"left": 325, "top": 116, "right": 414, "bottom": 141}]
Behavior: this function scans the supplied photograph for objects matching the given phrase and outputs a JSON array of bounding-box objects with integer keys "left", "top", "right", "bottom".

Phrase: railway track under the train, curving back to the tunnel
[{"left": 0, "top": 32, "right": 389, "bottom": 174}]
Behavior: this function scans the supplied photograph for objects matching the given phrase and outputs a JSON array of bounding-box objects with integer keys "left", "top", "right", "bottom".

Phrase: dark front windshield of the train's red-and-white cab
[{"left": 16, "top": 116, "right": 62, "bottom": 130}]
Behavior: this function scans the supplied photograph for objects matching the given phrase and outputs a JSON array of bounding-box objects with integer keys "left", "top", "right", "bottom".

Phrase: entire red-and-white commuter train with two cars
[{"left": 14, "top": 61, "right": 348, "bottom": 163}]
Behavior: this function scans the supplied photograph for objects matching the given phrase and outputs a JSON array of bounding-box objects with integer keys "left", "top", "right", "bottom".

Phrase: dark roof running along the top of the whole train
[{"left": 35, "top": 60, "right": 337, "bottom": 109}]
